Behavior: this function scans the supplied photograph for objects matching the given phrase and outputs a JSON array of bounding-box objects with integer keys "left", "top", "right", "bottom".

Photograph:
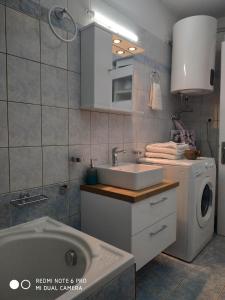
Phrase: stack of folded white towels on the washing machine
[{"left": 145, "top": 141, "right": 189, "bottom": 159}]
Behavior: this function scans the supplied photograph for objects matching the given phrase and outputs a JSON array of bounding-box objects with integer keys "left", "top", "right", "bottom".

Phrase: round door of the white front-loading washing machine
[{"left": 197, "top": 178, "right": 214, "bottom": 227}]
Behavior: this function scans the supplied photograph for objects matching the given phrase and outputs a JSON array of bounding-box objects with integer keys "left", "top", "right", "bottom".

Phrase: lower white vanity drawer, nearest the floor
[{"left": 131, "top": 213, "right": 176, "bottom": 270}]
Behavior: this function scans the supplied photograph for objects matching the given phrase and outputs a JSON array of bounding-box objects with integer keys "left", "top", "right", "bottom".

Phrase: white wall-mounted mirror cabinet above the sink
[{"left": 81, "top": 23, "right": 137, "bottom": 113}]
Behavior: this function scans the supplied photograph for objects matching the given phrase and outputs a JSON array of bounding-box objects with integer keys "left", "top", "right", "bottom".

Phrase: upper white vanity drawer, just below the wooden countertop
[{"left": 131, "top": 189, "right": 176, "bottom": 235}]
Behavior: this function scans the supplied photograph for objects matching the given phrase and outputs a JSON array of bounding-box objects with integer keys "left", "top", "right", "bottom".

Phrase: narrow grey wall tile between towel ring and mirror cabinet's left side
[{"left": 68, "top": 33, "right": 80, "bottom": 73}]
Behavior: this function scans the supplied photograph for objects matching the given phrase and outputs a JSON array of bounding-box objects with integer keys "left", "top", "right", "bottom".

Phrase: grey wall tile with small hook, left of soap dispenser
[{"left": 69, "top": 145, "right": 91, "bottom": 182}]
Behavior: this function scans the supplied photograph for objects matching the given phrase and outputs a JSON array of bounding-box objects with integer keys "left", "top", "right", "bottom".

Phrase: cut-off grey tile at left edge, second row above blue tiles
[{"left": 0, "top": 101, "right": 8, "bottom": 147}]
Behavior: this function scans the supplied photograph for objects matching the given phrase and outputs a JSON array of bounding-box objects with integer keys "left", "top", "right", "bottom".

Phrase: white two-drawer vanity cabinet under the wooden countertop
[{"left": 81, "top": 185, "right": 176, "bottom": 270}]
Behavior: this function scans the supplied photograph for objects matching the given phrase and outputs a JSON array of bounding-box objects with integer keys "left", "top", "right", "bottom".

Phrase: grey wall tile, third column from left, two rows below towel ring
[{"left": 42, "top": 106, "right": 69, "bottom": 145}]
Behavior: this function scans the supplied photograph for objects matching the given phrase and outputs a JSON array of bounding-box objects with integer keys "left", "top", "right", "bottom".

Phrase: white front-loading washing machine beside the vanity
[{"left": 140, "top": 157, "right": 216, "bottom": 262}]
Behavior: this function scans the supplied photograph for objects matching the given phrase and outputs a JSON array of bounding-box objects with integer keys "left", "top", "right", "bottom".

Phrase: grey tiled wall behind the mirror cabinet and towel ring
[{"left": 0, "top": 0, "right": 176, "bottom": 227}]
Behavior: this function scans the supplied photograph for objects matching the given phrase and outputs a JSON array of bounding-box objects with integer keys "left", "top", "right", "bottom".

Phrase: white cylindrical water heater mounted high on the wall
[{"left": 171, "top": 16, "right": 217, "bottom": 95}]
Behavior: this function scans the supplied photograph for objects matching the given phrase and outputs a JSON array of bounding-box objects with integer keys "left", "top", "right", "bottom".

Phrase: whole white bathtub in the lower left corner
[{"left": 0, "top": 217, "right": 134, "bottom": 300}]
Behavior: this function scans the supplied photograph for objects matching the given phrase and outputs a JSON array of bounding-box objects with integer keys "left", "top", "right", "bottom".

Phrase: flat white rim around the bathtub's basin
[{"left": 0, "top": 216, "right": 135, "bottom": 300}]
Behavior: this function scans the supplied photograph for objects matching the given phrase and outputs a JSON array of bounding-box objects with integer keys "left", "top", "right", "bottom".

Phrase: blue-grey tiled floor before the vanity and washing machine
[{"left": 137, "top": 236, "right": 225, "bottom": 300}]
